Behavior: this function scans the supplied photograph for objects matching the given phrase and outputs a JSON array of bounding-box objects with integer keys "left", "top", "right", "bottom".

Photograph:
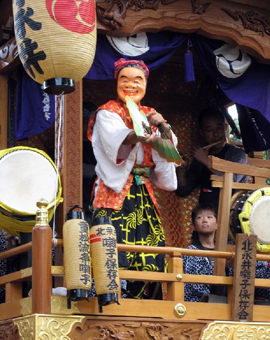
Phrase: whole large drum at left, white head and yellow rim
[{"left": 0, "top": 146, "right": 63, "bottom": 236}]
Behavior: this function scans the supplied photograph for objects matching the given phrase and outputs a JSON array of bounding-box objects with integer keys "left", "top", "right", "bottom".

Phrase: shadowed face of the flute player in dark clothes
[{"left": 201, "top": 117, "right": 226, "bottom": 151}]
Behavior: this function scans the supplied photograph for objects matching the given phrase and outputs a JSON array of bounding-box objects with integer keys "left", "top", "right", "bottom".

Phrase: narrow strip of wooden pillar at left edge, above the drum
[{"left": 0, "top": 74, "right": 8, "bottom": 150}]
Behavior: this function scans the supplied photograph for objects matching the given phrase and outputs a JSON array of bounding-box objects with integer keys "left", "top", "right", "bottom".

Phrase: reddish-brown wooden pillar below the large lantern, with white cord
[{"left": 55, "top": 81, "right": 83, "bottom": 286}]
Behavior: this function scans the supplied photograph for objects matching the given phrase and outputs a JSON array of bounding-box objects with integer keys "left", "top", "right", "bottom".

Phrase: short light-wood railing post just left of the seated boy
[{"left": 167, "top": 251, "right": 184, "bottom": 301}]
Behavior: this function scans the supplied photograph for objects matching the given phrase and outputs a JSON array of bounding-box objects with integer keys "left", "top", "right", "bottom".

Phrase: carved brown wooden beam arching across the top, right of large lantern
[{"left": 96, "top": 0, "right": 270, "bottom": 63}]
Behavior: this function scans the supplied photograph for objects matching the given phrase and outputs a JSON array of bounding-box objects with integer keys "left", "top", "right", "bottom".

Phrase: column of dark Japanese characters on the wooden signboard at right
[{"left": 238, "top": 239, "right": 252, "bottom": 320}]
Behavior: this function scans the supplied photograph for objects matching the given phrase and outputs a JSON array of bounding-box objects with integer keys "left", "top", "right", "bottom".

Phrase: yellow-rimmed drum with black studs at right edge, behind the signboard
[{"left": 239, "top": 187, "right": 270, "bottom": 252}]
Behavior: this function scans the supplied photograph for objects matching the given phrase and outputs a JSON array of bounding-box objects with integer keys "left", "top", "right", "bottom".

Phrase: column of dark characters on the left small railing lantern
[{"left": 78, "top": 221, "right": 90, "bottom": 285}]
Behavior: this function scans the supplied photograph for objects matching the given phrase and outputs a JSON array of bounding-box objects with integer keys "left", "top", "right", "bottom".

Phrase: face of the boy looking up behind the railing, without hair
[{"left": 193, "top": 210, "right": 217, "bottom": 234}]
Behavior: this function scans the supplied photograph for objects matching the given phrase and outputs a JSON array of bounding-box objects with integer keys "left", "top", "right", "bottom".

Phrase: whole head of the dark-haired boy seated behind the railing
[{"left": 191, "top": 203, "right": 217, "bottom": 239}]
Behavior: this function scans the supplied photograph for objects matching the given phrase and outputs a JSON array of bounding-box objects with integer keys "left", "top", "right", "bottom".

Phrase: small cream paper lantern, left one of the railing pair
[{"left": 63, "top": 205, "right": 91, "bottom": 309}]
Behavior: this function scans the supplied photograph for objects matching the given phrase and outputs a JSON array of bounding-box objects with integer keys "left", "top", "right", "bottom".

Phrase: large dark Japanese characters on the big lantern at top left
[{"left": 14, "top": 0, "right": 46, "bottom": 78}]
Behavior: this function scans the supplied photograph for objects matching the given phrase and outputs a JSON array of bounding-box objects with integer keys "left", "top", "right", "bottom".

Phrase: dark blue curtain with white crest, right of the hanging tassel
[{"left": 191, "top": 35, "right": 270, "bottom": 152}]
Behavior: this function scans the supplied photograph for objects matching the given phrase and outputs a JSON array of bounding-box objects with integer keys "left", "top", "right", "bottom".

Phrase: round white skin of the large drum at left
[{"left": 0, "top": 148, "right": 58, "bottom": 214}]
